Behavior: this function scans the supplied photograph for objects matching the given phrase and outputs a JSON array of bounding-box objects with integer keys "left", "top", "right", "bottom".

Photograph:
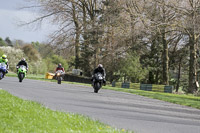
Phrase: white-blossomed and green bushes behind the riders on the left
[{"left": 0, "top": 38, "right": 69, "bottom": 74}]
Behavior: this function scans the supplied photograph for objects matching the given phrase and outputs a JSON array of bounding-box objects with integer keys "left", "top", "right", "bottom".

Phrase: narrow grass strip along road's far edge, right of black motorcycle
[{"left": 103, "top": 86, "right": 200, "bottom": 109}]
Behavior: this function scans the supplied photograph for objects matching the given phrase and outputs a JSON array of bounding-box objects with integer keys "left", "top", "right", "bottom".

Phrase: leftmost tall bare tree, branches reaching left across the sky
[{"left": 22, "top": 0, "right": 81, "bottom": 68}]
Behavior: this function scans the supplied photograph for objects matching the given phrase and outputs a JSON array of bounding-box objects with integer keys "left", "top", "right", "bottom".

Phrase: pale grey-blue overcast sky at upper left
[{"left": 0, "top": 0, "right": 55, "bottom": 42}]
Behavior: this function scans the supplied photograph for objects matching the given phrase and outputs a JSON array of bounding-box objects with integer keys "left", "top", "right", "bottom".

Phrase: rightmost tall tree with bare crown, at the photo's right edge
[{"left": 168, "top": 0, "right": 200, "bottom": 93}]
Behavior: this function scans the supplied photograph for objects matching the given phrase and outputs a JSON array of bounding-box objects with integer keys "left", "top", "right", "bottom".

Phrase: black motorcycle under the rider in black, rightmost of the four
[{"left": 92, "top": 73, "right": 103, "bottom": 93}]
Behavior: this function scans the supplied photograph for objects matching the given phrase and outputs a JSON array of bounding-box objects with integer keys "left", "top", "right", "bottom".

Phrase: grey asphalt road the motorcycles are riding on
[{"left": 0, "top": 77, "right": 200, "bottom": 133}]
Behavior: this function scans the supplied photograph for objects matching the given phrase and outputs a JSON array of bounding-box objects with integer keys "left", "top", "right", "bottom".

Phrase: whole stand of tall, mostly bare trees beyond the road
[{"left": 12, "top": 0, "right": 200, "bottom": 93}]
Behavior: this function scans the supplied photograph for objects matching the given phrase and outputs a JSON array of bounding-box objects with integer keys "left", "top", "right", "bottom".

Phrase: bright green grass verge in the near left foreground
[{"left": 0, "top": 90, "right": 128, "bottom": 133}]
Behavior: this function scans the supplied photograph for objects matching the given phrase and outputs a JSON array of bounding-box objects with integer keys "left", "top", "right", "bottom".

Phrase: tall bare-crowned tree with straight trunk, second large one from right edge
[{"left": 145, "top": 0, "right": 178, "bottom": 85}]
